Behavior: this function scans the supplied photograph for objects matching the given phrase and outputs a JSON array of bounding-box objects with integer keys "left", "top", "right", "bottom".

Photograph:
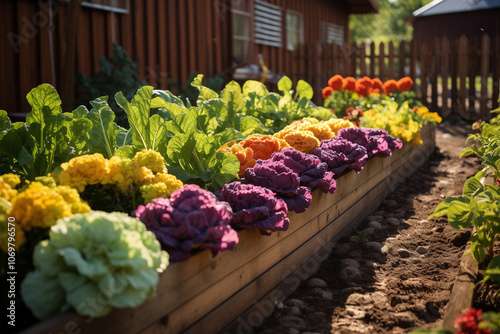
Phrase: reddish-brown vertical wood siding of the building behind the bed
[{"left": 0, "top": 0, "right": 349, "bottom": 116}]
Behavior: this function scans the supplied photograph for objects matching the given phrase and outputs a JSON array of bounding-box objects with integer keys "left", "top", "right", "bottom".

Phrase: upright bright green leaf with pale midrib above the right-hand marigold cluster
[{"left": 115, "top": 86, "right": 153, "bottom": 150}]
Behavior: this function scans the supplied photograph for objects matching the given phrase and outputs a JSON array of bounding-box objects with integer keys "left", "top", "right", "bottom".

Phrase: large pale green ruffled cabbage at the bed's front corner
[{"left": 21, "top": 211, "right": 168, "bottom": 319}]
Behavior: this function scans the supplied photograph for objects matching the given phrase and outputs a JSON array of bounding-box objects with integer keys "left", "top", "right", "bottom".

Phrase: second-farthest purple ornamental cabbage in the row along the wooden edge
[{"left": 312, "top": 136, "right": 368, "bottom": 174}]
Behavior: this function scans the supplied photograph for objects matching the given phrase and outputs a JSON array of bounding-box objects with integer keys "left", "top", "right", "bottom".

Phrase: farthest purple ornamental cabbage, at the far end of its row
[{"left": 338, "top": 128, "right": 403, "bottom": 158}]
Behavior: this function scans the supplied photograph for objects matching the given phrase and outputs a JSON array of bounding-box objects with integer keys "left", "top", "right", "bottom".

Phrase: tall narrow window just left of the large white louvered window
[{"left": 231, "top": 0, "right": 252, "bottom": 63}]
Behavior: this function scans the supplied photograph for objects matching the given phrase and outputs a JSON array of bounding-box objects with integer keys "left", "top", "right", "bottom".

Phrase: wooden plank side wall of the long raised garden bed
[{"left": 24, "top": 125, "right": 435, "bottom": 334}]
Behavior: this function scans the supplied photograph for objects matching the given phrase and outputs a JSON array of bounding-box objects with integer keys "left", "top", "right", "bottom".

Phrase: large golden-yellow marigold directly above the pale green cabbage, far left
[{"left": 10, "top": 182, "right": 72, "bottom": 231}]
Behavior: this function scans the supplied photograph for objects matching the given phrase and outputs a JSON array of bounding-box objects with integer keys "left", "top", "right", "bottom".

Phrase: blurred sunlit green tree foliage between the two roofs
[{"left": 349, "top": 0, "right": 432, "bottom": 44}]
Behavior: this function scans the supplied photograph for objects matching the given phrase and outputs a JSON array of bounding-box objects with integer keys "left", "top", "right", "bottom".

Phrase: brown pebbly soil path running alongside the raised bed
[{"left": 255, "top": 121, "right": 492, "bottom": 334}]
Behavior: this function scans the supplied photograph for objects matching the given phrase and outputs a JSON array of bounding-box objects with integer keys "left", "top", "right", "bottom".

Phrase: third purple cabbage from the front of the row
[{"left": 244, "top": 161, "right": 312, "bottom": 213}]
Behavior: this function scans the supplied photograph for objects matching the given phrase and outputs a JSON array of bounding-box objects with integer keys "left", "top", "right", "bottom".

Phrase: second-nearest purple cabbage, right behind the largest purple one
[{"left": 216, "top": 181, "right": 290, "bottom": 234}]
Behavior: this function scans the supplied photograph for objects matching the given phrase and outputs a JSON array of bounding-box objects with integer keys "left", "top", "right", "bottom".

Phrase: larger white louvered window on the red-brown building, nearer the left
[{"left": 254, "top": 0, "right": 282, "bottom": 47}]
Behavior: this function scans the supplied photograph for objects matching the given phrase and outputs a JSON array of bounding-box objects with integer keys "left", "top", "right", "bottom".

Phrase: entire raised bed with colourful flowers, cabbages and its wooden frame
[{"left": 0, "top": 76, "right": 440, "bottom": 332}]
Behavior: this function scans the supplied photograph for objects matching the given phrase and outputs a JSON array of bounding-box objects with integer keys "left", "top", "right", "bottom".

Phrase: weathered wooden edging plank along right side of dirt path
[{"left": 443, "top": 244, "right": 479, "bottom": 331}]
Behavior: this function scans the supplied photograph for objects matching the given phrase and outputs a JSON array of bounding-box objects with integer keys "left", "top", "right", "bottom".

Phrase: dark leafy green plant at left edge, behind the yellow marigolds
[{"left": 0, "top": 84, "right": 92, "bottom": 180}]
